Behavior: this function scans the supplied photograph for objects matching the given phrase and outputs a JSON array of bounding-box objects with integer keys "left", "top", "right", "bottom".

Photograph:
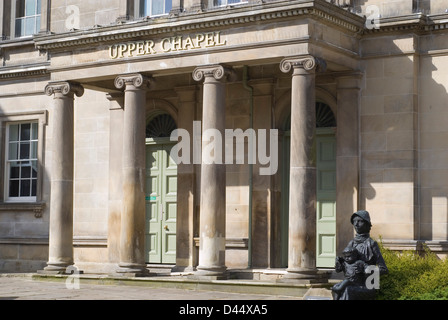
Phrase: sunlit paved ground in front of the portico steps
[{"left": 0, "top": 276, "right": 298, "bottom": 301}]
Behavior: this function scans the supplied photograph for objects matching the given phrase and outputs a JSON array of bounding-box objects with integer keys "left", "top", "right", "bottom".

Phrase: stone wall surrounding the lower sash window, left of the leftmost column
[{"left": 0, "top": 78, "right": 52, "bottom": 272}]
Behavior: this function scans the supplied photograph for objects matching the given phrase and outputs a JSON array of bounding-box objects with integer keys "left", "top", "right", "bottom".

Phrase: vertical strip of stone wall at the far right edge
[{"left": 418, "top": 34, "right": 448, "bottom": 240}]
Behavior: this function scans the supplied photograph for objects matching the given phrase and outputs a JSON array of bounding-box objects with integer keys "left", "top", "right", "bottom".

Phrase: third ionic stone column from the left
[{"left": 193, "top": 65, "right": 231, "bottom": 277}]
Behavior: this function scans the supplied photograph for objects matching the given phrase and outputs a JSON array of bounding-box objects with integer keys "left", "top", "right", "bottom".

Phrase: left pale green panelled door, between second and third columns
[{"left": 145, "top": 143, "right": 177, "bottom": 264}]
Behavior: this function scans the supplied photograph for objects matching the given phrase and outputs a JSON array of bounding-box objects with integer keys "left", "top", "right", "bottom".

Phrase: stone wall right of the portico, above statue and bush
[{"left": 360, "top": 36, "right": 448, "bottom": 240}]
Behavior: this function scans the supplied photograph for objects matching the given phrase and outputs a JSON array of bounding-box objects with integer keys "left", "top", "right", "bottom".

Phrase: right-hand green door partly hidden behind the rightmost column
[{"left": 280, "top": 128, "right": 336, "bottom": 268}]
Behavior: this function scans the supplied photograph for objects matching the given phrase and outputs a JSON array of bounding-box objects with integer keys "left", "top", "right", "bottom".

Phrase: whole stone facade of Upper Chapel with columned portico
[{"left": 0, "top": 0, "right": 448, "bottom": 278}]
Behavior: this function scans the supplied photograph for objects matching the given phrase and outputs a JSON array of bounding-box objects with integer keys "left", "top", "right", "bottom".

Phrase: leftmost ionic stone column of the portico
[{"left": 44, "top": 82, "right": 84, "bottom": 273}]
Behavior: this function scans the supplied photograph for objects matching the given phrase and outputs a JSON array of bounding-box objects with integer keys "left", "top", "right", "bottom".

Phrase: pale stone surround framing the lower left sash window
[{"left": 0, "top": 111, "right": 47, "bottom": 204}]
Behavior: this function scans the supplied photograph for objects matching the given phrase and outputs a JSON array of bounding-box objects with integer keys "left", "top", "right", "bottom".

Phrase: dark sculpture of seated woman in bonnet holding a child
[{"left": 331, "top": 210, "right": 388, "bottom": 300}]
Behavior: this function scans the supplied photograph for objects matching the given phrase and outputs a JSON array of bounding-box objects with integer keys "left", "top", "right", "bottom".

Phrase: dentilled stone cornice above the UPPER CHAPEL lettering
[{"left": 34, "top": 0, "right": 365, "bottom": 50}]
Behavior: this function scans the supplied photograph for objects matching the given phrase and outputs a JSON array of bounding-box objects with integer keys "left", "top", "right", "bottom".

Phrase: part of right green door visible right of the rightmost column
[{"left": 316, "top": 129, "right": 336, "bottom": 268}]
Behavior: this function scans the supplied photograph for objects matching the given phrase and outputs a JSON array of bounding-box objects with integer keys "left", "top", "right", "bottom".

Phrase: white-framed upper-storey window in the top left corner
[{"left": 14, "top": 0, "right": 41, "bottom": 38}]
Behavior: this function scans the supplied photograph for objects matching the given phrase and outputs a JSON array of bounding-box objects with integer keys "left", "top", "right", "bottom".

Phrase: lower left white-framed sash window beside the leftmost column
[{"left": 4, "top": 121, "right": 39, "bottom": 202}]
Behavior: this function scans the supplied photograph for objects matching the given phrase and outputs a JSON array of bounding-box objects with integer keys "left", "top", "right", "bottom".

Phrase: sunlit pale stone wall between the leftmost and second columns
[{"left": 73, "top": 90, "right": 110, "bottom": 272}]
